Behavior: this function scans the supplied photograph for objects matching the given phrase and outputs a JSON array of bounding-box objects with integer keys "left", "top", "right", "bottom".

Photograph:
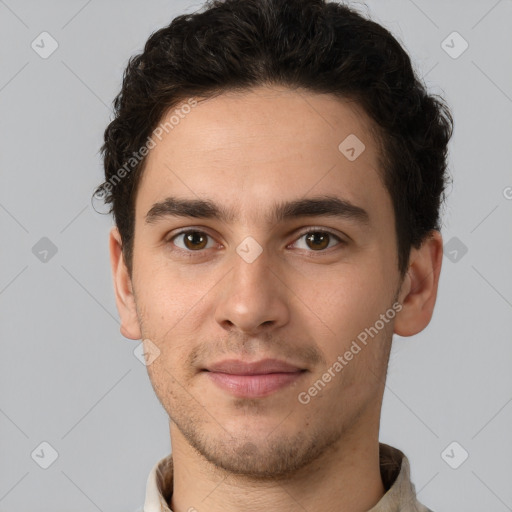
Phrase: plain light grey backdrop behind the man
[{"left": 0, "top": 0, "right": 512, "bottom": 512}]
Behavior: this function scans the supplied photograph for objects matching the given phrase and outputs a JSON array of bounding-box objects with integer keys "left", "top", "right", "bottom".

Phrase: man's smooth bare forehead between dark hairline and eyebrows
[{"left": 136, "top": 87, "right": 391, "bottom": 227}]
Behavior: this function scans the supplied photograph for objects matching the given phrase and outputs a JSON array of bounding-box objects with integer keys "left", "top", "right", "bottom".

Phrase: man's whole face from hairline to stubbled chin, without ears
[{"left": 113, "top": 88, "right": 420, "bottom": 477}]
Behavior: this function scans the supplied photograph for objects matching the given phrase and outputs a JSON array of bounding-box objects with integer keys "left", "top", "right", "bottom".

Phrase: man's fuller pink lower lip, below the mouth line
[{"left": 206, "top": 371, "right": 304, "bottom": 398}]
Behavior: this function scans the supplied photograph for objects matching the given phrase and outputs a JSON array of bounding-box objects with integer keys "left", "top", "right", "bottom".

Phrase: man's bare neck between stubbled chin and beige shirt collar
[{"left": 170, "top": 422, "right": 386, "bottom": 512}]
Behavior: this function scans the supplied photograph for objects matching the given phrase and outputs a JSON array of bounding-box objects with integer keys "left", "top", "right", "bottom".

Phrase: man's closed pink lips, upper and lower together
[{"left": 205, "top": 359, "right": 306, "bottom": 398}]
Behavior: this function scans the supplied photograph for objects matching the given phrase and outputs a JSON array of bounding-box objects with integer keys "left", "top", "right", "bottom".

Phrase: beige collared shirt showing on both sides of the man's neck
[{"left": 143, "top": 443, "right": 432, "bottom": 512}]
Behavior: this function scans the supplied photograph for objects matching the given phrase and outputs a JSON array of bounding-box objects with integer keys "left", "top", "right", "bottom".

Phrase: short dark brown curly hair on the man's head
[{"left": 95, "top": 0, "right": 453, "bottom": 277}]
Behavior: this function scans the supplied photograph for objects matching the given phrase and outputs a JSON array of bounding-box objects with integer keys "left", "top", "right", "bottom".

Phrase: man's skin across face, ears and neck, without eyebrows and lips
[{"left": 110, "top": 87, "right": 442, "bottom": 512}]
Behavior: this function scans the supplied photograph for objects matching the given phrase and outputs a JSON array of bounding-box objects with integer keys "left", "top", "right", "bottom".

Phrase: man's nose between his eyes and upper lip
[{"left": 215, "top": 245, "right": 290, "bottom": 335}]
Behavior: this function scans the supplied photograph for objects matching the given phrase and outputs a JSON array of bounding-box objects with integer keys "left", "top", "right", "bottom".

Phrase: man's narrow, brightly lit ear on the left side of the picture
[{"left": 109, "top": 227, "right": 142, "bottom": 340}]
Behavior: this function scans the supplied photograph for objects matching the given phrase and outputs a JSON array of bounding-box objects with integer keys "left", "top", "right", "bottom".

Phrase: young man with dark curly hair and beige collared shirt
[{"left": 99, "top": 0, "right": 452, "bottom": 512}]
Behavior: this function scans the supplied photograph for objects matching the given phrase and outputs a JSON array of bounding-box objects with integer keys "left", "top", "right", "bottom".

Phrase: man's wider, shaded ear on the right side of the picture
[{"left": 394, "top": 230, "right": 443, "bottom": 336}]
